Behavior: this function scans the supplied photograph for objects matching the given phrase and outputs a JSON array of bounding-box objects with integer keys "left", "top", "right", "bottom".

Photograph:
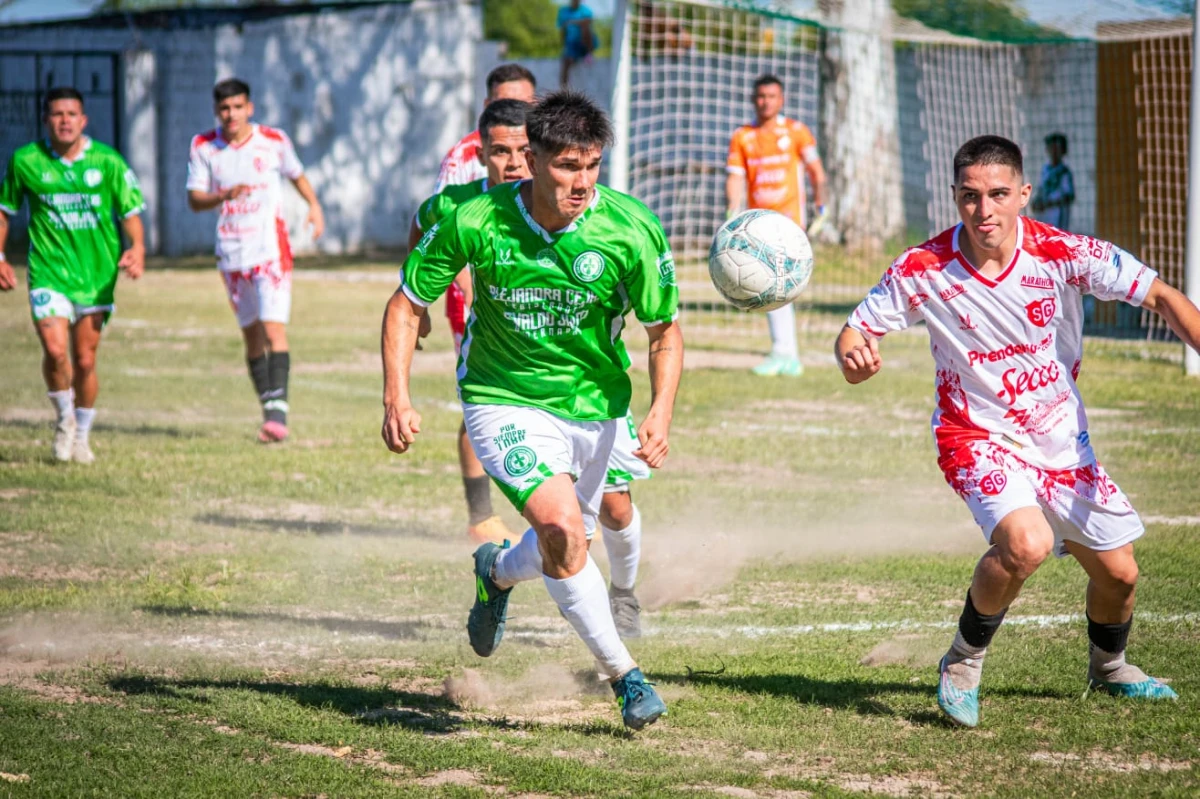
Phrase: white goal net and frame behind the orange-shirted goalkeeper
[{"left": 614, "top": 0, "right": 1192, "bottom": 350}]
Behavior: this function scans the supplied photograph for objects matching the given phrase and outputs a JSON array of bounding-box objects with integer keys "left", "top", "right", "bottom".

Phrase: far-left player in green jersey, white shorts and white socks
[{"left": 0, "top": 86, "right": 145, "bottom": 463}]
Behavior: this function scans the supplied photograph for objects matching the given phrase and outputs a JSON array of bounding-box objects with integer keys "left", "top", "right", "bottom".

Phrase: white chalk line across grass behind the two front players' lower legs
[{"left": 508, "top": 613, "right": 1200, "bottom": 639}]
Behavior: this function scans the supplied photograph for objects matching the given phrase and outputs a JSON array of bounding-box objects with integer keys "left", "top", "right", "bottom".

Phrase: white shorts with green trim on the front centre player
[{"left": 462, "top": 403, "right": 622, "bottom": 539}]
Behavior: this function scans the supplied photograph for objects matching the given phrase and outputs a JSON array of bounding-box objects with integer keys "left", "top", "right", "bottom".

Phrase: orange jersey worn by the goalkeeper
[{"left": 726, "top": 114, "right": 820, "bottom": 226}]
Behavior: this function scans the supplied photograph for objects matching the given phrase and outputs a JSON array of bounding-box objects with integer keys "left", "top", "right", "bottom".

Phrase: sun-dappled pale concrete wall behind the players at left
[{"left": 0, "top": 0, "right": 480, "bottom": 256}]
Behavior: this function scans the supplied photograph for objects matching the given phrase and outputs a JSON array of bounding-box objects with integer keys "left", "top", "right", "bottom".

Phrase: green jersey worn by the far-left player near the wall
[{"left": 0, "top": 138, "right": 145, "bottom": 305}]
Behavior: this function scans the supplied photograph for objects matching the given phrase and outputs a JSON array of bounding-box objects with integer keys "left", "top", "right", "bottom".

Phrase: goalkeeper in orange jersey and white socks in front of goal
[{"left": 725, "top": 74, "right": 826, "bottom": 377}]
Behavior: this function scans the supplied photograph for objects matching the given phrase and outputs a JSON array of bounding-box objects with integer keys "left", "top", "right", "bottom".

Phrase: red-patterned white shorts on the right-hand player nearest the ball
[{"left": 938, "top": 440, "right": 1146, "bottom": 558}]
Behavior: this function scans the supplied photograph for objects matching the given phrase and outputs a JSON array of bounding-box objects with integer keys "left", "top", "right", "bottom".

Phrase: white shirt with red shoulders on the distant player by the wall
[{"left": 187, "top": 125, "right": 304, "bottom": 271}]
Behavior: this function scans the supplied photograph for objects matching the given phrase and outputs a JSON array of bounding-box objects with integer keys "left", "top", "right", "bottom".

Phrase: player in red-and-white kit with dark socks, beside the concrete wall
[{"left": 187, "top": 78, "right": 325, "bottom": 444}]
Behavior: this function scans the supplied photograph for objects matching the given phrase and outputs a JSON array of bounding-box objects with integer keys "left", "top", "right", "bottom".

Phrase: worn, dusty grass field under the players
[{"left": 0, "top": 264, "right": 1200, "bottom": 799}]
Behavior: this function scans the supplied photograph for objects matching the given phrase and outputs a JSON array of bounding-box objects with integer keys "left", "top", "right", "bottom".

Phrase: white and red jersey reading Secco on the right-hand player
[{"left": 847, "top": 217, "right": 1157, "bottom": 470}]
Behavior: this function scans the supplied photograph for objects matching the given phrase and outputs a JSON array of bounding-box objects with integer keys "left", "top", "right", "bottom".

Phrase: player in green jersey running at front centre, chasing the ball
[{"left": 383, "top": 91, "right": 683, "bottom": 729}]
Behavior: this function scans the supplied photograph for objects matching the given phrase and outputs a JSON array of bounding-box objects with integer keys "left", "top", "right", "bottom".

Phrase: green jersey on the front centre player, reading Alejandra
[{"left": 403, "top": 181, "right": 679, "bottom": 421}]
